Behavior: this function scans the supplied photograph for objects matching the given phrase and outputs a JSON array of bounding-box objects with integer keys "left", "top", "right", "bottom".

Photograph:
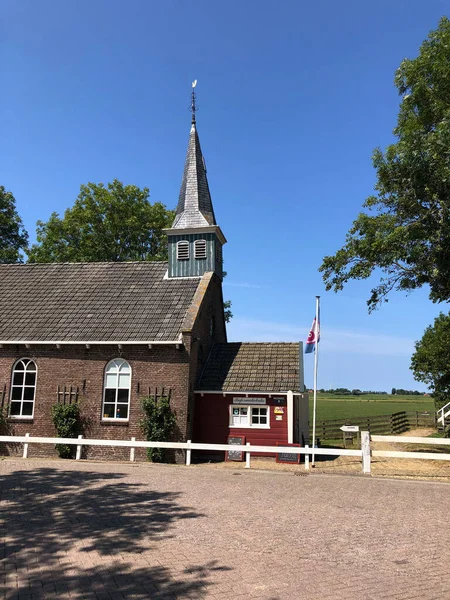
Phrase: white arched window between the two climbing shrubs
[{"left": 103, "top": 358, "right": 131, "bottom": 420}]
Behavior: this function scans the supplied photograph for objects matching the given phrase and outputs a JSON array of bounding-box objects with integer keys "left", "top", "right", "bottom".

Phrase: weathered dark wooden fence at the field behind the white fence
[{"left": 311, "top": 411, "right": 436, "bottom": 440}]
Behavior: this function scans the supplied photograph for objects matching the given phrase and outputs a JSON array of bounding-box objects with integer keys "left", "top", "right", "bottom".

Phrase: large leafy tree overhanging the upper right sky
[{"left": 320, "top": 17, "right": 450, "bottom": 311}]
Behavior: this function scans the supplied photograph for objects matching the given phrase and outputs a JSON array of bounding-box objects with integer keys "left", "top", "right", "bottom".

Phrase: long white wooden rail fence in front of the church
[{"left": 0, "top": 431, "right": 450, "bottom": 474}]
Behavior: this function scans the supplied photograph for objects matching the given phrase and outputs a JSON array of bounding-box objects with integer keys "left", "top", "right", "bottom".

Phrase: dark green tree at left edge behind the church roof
[{"left": 0, "top": 185, "right": 28, "bottom": 263}]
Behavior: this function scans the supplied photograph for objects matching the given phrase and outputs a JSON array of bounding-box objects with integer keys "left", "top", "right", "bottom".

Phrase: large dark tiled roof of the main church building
[{"left": 0, "top": 262, "right": 200, "bottom": 341}]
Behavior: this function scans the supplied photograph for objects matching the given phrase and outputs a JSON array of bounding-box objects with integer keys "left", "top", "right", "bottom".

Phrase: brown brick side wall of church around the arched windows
[{"left": 0, "top": 345, "right": 190, "bottom": 460}]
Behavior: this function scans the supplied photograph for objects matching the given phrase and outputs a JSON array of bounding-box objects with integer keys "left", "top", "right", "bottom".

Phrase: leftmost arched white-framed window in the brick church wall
[{"left": 9, "top": 358, "right": 37, "bottom": 418}]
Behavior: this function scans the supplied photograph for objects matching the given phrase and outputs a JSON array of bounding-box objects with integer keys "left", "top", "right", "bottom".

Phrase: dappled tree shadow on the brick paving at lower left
[{"left": 0, "top": 468, "right": 228, "bottom": 600}]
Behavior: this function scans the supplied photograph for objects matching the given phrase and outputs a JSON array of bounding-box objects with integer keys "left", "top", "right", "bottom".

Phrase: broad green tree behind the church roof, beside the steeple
[{"left": 29, "top": 179, "right": 174, "bottom": 262}]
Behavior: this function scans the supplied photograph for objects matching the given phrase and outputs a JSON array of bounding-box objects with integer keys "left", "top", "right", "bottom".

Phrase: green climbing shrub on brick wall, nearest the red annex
[{"left": 139, "top": 396, "right": 176, "bottom": 462}]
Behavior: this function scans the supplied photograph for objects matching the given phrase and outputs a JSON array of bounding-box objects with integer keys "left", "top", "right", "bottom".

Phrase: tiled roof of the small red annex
[{"left": 198, "top": 342, "right": 303, "bottom": 392}]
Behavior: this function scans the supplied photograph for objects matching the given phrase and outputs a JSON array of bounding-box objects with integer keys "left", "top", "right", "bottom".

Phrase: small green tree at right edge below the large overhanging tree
[{"left": 411, "top": 313, "right": 450, "bottom": 409}]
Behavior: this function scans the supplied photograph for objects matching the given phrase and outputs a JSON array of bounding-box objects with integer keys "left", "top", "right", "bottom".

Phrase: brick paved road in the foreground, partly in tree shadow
[{"left": 0, "top": 459, "right": 450, "bottom": 600}]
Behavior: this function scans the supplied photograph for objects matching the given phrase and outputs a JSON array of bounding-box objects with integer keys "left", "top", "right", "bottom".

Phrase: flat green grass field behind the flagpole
[{"left": 309, "top": 394, "right": 434, "bottom": 423}]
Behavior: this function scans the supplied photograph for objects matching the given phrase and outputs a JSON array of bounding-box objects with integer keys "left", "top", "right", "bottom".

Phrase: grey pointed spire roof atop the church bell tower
[{"left": 172, "top": 120, "right": 217, "bottom": 229}]
